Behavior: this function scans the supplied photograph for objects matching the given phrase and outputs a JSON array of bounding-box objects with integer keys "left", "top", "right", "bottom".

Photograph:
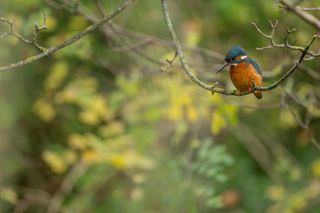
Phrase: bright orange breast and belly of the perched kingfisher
[{"left": 230, "top": 62, "right": 262, "bottom": 92}]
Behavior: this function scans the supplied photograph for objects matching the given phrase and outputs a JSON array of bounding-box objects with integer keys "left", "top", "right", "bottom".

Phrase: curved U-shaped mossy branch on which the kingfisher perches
[{"left": 161, "top": 0, "right": 317, "bottom": 96}]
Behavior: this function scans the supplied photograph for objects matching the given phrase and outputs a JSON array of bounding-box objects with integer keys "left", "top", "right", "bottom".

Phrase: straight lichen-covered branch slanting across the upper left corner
[{"left": 0, "top": 0, "right": 134, "bottom": 71}]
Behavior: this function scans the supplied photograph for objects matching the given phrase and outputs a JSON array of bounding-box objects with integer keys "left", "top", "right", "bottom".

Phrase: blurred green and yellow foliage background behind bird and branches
[{"left": 0, "top": 0, "right": 320, "bottom": 213}]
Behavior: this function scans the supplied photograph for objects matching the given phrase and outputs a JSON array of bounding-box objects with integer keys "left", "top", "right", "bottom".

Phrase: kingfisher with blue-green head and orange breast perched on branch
[{"left": 217, "top": 46, "right": 262, "bottom": 99}]
